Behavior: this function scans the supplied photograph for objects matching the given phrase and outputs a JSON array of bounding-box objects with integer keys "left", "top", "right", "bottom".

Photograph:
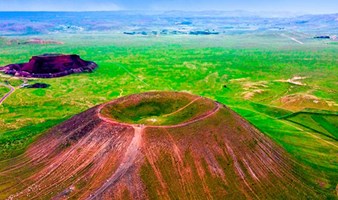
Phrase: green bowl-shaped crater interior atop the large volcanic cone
[{"left": 100, "top": 92, "right": 216, "bottom": 126}]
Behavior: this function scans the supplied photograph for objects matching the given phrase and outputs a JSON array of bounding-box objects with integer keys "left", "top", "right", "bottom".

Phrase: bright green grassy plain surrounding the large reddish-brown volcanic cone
[{"left": 0, "top": 34, "right": 338, "bottom": 194}]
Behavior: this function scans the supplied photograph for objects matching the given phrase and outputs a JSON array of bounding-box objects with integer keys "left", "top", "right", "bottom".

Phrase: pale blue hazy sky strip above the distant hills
[{"left": 0, "top": 0, "right": 338, "bottom": 13}]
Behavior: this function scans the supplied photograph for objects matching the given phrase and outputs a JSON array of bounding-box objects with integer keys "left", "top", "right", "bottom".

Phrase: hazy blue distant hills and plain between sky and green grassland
[{"left": 0, "top": 11, "right": 338, "bottom": 36}]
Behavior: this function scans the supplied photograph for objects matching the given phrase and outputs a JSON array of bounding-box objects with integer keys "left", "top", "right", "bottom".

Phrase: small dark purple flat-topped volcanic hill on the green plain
[{"left": 0, "top": 54, "right": 97, "bottom": 78}]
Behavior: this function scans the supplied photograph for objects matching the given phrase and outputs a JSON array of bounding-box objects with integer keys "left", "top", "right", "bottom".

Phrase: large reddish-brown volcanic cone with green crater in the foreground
[{"left": 0, "top": 92, "right": 319, "bottom": 199}]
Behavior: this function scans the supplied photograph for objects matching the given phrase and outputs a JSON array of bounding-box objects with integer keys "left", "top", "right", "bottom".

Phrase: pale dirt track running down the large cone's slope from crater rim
[{"left": 88, "top": 125, "right": 144, "bottom": 200}]
